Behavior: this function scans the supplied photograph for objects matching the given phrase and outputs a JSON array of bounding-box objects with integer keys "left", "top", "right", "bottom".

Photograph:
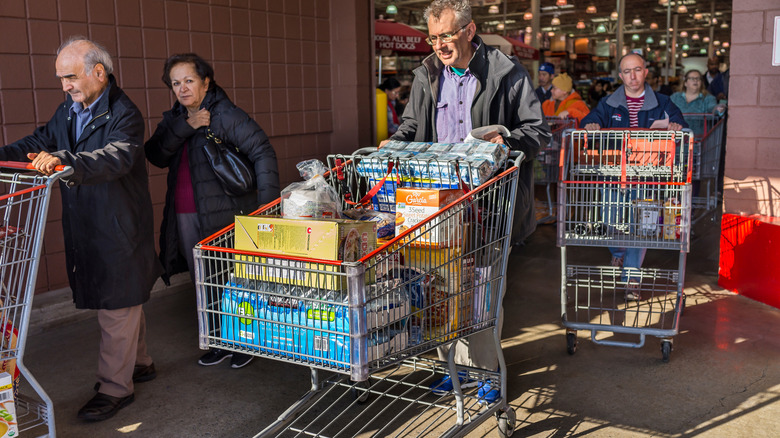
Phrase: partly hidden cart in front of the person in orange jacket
[{"left": 534, "top": 116, "right": 578, "bottom": 224}]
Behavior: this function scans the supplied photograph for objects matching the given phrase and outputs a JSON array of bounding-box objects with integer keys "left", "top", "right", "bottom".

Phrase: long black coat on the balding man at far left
[{"left": 0, "top": 75, "right": 160, "bottom": 309}]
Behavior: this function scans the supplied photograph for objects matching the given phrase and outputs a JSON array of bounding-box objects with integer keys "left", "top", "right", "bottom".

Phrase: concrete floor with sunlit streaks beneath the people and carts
[{"left": 16, "top": 217, "right": 780, "bottom": 437}]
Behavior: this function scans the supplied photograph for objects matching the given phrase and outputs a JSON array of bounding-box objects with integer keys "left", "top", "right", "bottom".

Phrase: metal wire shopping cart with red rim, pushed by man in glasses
[{"left": 194, "top": 150, "right": 522, "bottom": 436}]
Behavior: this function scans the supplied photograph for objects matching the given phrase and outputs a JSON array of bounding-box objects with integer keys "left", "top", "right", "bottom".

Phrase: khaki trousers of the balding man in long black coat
[{"left": 97, "top": 305, "right": 152, "bottom": 397}]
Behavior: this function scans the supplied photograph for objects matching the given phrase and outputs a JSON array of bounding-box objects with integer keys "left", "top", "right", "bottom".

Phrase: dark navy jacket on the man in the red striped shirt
[{"left": 580, "top": 84, "right": 688, "bottom": 128}]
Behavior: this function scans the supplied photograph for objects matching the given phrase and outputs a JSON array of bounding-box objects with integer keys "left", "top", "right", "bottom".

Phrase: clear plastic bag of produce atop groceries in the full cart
[{"left": 282, "top": 160, "right": 341, "bottom": 219}]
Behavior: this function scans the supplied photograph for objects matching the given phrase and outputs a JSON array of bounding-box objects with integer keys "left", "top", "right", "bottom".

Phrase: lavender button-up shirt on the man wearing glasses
[{"left": 436, "top": 66, "right": 477, "bottom": 143}]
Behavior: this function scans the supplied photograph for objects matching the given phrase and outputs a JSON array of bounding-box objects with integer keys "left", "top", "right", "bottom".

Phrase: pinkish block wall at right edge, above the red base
[{"left": 723, "top": 0, "right": 780, "bottom": 217}]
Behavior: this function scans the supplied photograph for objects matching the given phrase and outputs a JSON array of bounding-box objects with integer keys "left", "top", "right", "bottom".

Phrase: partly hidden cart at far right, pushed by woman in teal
[{"left": 683, "top": 113, "right": 726, "bottom": 223}]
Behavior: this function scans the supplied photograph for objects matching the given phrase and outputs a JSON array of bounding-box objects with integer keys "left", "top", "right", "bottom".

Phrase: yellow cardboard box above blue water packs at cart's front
[{"left": 235, "top": 216, "right": 376, "bottom": 289}]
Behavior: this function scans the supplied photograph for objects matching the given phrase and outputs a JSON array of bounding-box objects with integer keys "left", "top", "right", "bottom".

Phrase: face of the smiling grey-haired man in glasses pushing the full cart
[{"left": 428, "top": 9, "right": 476, "bottom": 68}]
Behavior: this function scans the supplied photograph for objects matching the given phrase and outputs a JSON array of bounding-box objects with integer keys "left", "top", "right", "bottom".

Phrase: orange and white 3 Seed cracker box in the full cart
[{"left": 395, "top": 187, "right": 463, "bottom": 247}]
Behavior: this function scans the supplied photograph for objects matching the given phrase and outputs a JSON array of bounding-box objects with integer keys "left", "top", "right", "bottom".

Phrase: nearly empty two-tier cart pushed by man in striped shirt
[{"left": 558, "top": 130, "right": 693, "bottom": 362}]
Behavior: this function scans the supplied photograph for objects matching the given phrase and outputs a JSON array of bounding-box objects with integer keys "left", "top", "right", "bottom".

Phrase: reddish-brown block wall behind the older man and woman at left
[{"left": 0, "top": 0, "right": 373, "bottom": 291}]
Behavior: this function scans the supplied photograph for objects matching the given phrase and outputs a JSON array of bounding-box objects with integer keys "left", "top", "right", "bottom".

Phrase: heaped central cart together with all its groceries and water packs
[{"left": 194, "top": 141, "right": 523, "bottom": 436}]
